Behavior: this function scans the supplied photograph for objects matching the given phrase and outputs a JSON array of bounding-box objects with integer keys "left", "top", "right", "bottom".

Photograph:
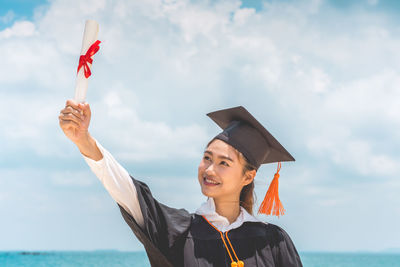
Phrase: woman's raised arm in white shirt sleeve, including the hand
[{"left": 59, "top": 100, "right": 143, "bottom": 226}]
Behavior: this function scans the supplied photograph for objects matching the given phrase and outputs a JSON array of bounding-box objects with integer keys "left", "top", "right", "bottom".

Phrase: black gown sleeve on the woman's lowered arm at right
[{"left": 272, "top": 225, "right": 303, "bottom": 267}]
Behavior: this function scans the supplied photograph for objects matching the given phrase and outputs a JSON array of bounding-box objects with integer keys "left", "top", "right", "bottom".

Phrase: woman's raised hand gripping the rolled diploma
[{"left": 58, "top": 99, "right": 91, "bottom": 146}]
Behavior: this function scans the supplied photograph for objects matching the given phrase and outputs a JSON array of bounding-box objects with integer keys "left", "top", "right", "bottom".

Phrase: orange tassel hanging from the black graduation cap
[{"left": 258, "top": 162, "right": 285, "bottom": 217}]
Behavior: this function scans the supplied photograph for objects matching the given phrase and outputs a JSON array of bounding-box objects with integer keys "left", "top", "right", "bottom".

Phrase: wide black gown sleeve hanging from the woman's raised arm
[{"left": 119, "top": 177, "right": 192, "bottom": 267}]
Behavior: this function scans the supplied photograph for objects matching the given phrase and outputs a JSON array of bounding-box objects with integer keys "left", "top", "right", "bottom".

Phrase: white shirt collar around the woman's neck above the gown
[{"left": 195, "top": 197, "right": 261, "bottom": 232}]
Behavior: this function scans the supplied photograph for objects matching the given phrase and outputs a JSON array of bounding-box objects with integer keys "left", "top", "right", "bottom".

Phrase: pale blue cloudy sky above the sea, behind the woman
[{"left": 0, "top": 0, "right": 400, "bottom": 252}]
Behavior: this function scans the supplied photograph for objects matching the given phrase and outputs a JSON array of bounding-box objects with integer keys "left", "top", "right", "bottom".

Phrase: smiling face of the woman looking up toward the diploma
[{"left": 198, "top": 139, "right": 254, "bottom": 201}]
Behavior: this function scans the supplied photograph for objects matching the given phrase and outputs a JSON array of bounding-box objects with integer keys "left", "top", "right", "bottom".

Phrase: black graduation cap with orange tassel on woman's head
[{"left": 207, "top": 106, "right": 295, "bottom": 216}]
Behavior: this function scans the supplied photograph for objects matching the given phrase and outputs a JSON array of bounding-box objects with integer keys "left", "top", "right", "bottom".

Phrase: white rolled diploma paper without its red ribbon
[{"left": 74, "top": 20, "right": 99, "bottom": 103}]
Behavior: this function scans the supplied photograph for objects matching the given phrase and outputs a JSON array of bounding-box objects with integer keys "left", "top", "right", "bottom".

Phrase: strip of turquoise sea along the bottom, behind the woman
[{"left": 0, "top": 251, "right": 400, "bottom": 267}]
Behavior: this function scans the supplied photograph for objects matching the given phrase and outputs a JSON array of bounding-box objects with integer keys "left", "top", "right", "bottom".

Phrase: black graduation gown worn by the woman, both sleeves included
[{"left": 119, "top": 177, "right": 302, "bottom": 267}]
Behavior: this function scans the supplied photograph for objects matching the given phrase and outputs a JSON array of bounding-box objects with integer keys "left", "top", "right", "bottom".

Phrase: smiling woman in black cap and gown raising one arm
[{"left": 59, "top": 100, "right": 302, "bottom": 267}]
